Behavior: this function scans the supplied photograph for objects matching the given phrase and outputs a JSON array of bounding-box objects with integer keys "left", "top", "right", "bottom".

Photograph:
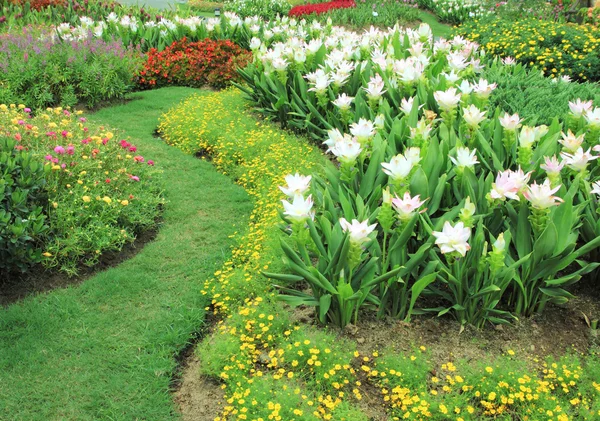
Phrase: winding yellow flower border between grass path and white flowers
[{"left": 159, "top": 90, "right": 600, "bottom": 421}]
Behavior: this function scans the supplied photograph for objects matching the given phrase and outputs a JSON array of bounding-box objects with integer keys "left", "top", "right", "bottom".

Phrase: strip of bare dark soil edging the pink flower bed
[{"left": 0, "top": 226, "right": 158, "bottom": 307}]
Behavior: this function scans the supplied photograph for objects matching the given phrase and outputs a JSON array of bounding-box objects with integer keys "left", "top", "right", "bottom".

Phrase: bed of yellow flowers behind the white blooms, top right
[{"left": 457, "top": 18, "right": 600, "bottom": 81}]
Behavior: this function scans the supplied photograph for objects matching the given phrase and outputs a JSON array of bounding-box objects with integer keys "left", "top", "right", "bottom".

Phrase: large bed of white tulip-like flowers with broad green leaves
[{"left": 232, "top": 21, "right": 600, "bottom": 327}]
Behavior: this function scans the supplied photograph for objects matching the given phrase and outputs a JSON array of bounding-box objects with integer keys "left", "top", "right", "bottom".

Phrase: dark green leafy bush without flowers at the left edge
[{"left": 0, "top": 136, "right": 48, "bottom": 274}]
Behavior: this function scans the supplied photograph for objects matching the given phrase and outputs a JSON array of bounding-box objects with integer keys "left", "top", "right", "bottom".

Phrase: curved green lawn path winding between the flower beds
[{"left": 0, "top": 88, "right": 251, "bottom": 421}]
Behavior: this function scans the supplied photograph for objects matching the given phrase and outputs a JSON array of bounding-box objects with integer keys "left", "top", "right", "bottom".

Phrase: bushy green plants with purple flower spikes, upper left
[{"left": 0, "top": 29, "right": 141, "bottom": 108}]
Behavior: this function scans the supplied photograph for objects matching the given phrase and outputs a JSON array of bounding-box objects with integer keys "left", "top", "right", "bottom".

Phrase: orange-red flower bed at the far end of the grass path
[{"left": 137, "top": 38, "right": 252, "bottom": 88}]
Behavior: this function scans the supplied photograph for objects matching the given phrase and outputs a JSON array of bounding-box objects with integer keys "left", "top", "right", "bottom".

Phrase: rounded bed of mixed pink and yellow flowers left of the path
[{"left": 0, "top": 105, "right": 163, "bottom": 274}]
